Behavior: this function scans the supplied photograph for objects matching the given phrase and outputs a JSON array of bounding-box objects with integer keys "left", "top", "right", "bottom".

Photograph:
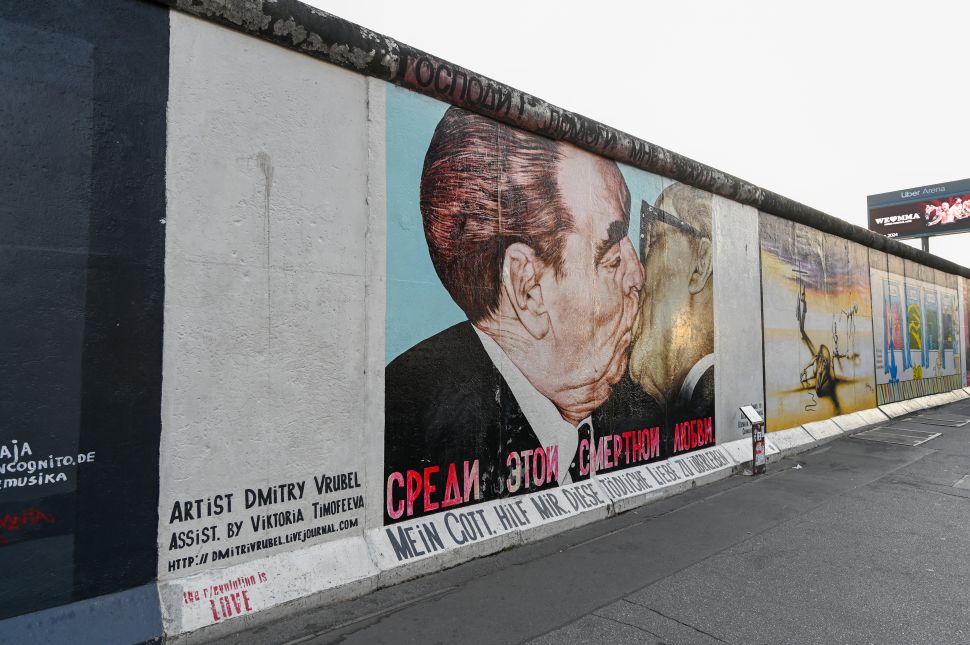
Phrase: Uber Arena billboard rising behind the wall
[{"left": 866, "top": 179, "right": 970, "bottom": 238}]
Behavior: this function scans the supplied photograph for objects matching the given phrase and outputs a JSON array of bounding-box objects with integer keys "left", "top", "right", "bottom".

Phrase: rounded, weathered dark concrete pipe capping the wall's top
[{"left": 155, "top": 0, "right": 970, "bottom": 278}]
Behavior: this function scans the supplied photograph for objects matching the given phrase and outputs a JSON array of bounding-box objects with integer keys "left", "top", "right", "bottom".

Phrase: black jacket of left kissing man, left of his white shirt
[{"left": 384, "top": 322, "right": 557, "bottom": 523}]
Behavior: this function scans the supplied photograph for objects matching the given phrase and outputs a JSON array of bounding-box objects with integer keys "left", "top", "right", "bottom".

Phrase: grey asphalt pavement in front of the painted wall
[{"left": 216, "top": 400, "right": 970, "bottom": 644}]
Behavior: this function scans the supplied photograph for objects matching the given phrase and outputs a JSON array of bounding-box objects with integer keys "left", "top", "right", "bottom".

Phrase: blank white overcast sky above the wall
[{"left": 310, "top": 0, "right": 970, "bottom": 265}]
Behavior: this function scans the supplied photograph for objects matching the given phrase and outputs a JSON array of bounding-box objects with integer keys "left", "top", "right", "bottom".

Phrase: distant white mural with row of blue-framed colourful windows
[{"left": 870, "top": 251, "right": 965, "bottom": 405}]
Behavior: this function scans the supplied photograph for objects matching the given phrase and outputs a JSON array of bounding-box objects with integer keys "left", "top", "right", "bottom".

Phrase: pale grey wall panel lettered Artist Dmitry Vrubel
[{"left": 158, "top": 12, "right": 375, "bottom": 633}]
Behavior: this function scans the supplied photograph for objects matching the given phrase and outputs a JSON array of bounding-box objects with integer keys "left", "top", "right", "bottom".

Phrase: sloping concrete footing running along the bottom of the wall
[{"left": 9, "top": 388, "right": 970, "bottom": 643}]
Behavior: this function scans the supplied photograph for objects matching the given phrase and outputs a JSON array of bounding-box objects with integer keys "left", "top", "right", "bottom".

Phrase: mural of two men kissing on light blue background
[{"left": 384, "top": 89, "right": 714, "bottom": 523}]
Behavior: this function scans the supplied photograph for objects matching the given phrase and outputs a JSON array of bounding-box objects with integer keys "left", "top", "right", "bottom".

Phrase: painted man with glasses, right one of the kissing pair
[{"left": 596, "top": 183, "right": 714, "bottom": 465}]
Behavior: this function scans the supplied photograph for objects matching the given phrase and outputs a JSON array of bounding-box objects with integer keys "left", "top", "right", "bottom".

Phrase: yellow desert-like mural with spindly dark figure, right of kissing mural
[{"left": 760, "top": 213, "right": 876, "bottom": 431}]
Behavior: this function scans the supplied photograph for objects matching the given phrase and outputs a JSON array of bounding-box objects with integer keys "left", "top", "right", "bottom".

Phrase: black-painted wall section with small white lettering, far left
[{"left": 0, "top": 0, "right": 169, "bottom": 619}]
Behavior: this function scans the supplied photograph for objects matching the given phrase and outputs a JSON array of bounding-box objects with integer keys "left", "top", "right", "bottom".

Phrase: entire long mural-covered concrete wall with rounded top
[{"left": 0, "top": 0, "right": 970, "bottom": 642}]
